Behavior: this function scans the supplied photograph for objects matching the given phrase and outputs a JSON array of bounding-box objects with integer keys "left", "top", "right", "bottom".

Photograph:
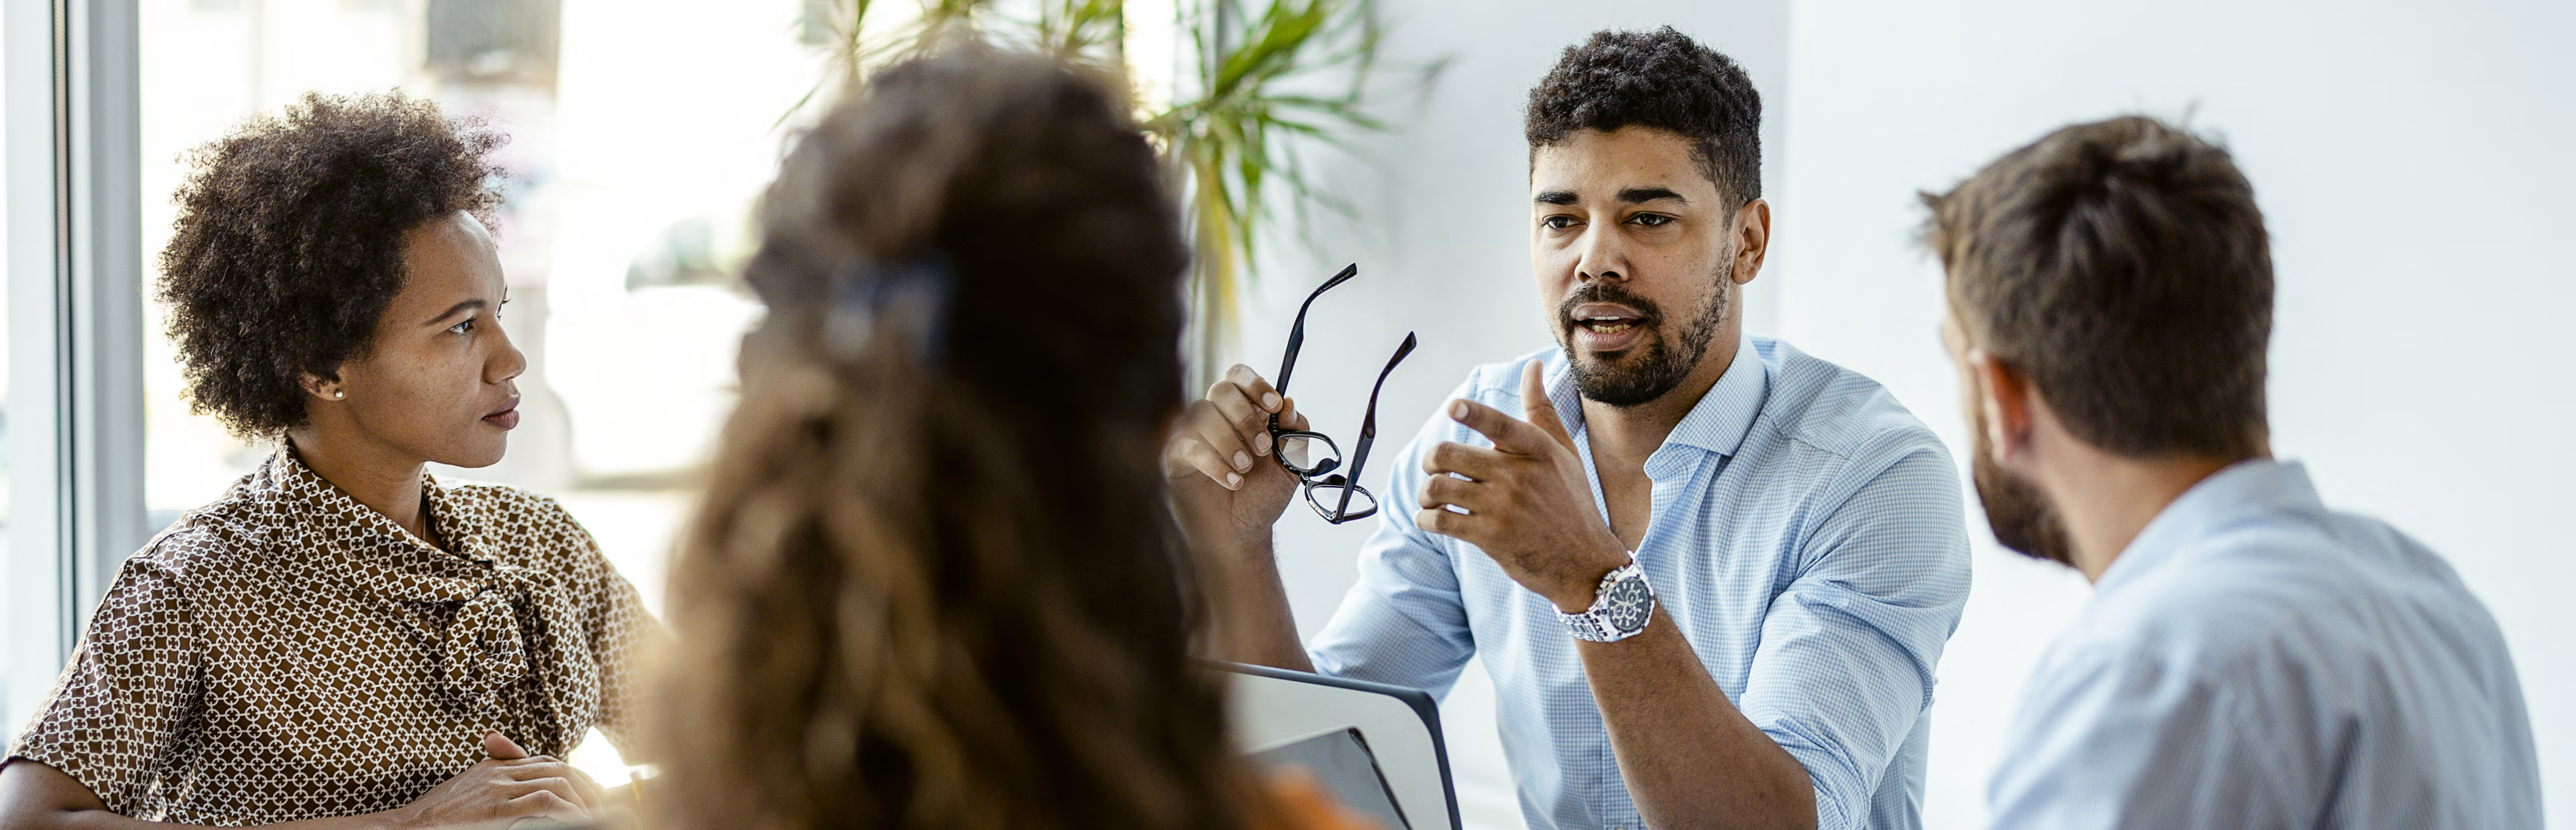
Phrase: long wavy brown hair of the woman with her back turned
[{"left": 662, "top": 49, "right": 1262, "bottom": 830}]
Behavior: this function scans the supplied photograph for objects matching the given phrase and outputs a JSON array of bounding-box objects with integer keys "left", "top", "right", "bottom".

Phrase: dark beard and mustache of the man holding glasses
[{"left": 1556, "top": 261, "right": 1736, "bottom": 407}]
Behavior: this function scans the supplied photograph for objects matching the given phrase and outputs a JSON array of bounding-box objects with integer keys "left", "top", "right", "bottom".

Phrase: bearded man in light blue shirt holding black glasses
[{"left": 1167, "top": 28, "right": 1968, "bottom": 830}]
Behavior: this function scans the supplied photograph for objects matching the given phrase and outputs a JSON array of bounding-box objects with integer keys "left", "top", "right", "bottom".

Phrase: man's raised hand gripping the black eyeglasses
[{"left": 1162, "top": 363, "right": 1306, "bottom": 552}]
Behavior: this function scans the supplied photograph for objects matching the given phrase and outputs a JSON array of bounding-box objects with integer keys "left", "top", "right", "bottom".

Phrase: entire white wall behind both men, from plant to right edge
[{"left": 1298, "top": 0, "right": 2576, "bottom": 827}]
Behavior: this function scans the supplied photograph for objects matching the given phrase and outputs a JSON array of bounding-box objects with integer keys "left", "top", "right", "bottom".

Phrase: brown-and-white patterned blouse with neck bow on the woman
[{"left": 10, "top": 451, "right": 665, "bottom": 825}]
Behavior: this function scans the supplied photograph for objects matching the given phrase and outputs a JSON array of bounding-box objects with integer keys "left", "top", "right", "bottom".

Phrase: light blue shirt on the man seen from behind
[{"left": 1991, "top": 459, "right": 2540, "bottom": 830}]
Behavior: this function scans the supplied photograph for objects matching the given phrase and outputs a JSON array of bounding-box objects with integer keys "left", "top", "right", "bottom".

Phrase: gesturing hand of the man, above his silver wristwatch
[{"left": 1414, "top": 361, "right": 1628, "bottom": 611}]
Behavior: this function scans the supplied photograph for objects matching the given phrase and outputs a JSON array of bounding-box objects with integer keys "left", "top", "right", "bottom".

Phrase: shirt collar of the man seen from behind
[{"left": 2094, "top": 459, "right": 2326, "bottom": 595}]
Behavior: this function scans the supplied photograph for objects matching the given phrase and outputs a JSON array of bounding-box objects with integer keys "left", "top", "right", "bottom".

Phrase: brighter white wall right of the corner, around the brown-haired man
[{"left": 1775, "top": 0, "right": 2576, "bottom": 827}]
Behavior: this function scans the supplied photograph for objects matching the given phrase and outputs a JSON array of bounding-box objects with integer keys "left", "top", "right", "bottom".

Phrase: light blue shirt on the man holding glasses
[{"left": 1311, "top": 337, "right": 1968, "bottom": 830}]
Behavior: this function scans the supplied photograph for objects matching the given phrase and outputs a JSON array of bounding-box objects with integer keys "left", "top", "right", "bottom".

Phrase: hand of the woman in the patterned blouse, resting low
[{"left": 392, "top": 732, "right": 608, "bottom": 827}]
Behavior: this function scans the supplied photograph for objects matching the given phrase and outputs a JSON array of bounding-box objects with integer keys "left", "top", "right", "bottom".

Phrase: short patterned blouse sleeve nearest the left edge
[{"left": 10, "top": 557, "right": 206, "bottom": 814}]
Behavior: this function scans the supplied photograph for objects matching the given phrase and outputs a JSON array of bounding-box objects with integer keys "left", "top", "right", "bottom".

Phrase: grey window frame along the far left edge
[{"left": 0, "top": 0, "right": 152, "bottom": 735}]
